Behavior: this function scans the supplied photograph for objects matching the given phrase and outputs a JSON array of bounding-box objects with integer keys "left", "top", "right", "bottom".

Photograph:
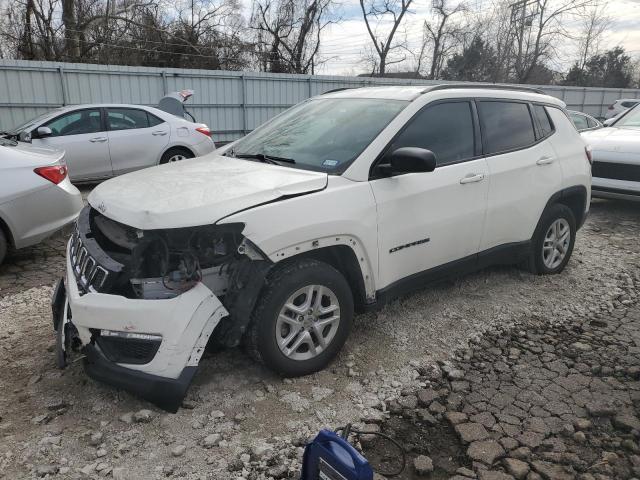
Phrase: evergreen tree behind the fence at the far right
[{"left": 564, "top": 47, "right": 633, "bottom": 88}]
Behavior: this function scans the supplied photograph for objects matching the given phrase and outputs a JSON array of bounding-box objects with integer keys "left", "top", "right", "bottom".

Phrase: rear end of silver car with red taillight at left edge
[{"left": 0, "top": 138, "right": 84, "bottom": 264}]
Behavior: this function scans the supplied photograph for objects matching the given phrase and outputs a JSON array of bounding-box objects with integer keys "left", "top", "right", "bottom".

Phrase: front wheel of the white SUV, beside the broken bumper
[{"left": 245, "top": 259, "right": 354, "bottom": 377}]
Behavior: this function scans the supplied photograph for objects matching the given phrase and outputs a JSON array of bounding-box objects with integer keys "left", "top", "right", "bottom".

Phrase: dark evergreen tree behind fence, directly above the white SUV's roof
[{"left": 442, "top": 35, "right": 498, "bottom": 82}]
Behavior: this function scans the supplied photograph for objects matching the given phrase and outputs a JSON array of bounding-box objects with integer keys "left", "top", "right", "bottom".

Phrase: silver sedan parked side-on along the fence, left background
[{"left": 5, "top": 104, "right": 215, "bottom": 182}]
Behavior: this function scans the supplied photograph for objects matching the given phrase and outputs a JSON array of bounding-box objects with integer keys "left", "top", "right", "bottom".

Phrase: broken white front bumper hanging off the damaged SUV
[{"left": 52, "top": 240, "right": 228, "bottom": 412}]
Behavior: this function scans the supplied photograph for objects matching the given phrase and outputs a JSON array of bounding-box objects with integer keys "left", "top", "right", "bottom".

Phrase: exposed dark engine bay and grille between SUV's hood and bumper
[{"left": 70, "top": 207, "right": 272, "bottom": 347}]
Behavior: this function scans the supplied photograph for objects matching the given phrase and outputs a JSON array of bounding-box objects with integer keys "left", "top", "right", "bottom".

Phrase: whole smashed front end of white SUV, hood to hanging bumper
[{"left": 53, "top": 157, "right": 326, "bottom": 411}]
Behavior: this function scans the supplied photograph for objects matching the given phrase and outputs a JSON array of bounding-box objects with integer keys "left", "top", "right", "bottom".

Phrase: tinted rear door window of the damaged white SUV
[{"left": 479, "top": 102, "right": 536, "bottom": 154}]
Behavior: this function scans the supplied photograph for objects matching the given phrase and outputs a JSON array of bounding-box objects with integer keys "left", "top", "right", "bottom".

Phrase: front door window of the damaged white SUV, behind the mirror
[{"left": 391, "top": 102, "right": 475, "bottom": 165}]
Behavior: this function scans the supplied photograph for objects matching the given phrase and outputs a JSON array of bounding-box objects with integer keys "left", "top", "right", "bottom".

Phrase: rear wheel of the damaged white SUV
[{"left": 528, "top": 203, "right": 577, "bottom": 275}]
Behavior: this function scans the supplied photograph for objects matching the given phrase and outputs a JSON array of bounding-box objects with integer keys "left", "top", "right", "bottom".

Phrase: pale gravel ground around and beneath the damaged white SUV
[{"left": 0, "top": 201, "right": 640, "bottom": 480}]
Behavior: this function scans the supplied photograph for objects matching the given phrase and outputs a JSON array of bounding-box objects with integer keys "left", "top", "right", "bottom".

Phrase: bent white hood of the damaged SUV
[{"left": 88, "top": 153, "right": 327, "bottom": 230}]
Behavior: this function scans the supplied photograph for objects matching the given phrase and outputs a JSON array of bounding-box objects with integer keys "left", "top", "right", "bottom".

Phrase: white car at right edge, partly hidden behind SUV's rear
[{"left": 582, "top": 106, "right": 640, "bottom": 201}]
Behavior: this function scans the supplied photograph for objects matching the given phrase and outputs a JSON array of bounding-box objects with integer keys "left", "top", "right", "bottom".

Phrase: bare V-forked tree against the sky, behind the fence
[{"left": 360, "top": 0, "right": 413, "bottom": 76}]
